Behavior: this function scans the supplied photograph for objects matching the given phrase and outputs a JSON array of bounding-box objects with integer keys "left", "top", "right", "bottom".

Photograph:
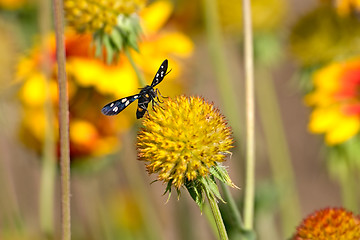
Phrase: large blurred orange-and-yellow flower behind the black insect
[{"left": 17, "top": 1, "right": 193, "bottom": 162}]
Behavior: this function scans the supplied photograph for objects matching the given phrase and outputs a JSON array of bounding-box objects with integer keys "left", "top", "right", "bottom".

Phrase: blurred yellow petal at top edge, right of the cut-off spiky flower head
[{"left": 140, "top": 0, "right": 173, "bottom": 34}]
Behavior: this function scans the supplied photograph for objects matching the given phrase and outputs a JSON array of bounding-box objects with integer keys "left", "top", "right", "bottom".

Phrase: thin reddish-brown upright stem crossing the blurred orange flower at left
[{"left": 53, "top": 0, "right": 71, "bottom": 240}]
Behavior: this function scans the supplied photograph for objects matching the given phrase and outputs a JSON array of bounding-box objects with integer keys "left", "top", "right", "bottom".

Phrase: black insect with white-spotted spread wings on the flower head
[{"left": 101, "top": 59, "right": 170, "bottom": 119}]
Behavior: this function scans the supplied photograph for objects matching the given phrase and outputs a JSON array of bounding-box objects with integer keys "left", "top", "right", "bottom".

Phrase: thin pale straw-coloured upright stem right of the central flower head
[{"left": 242, "top": 0, "right": 255, "bottom": 230}]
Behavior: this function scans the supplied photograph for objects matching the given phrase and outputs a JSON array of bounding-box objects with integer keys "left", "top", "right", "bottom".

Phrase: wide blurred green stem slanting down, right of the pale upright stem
[{"left": 256, "top": 68, "right": 301, "bottom": 236}]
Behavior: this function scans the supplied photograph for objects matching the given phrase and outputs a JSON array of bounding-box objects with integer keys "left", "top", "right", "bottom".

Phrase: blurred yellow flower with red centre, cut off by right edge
[{"left": 305, "top": 58, "right": 360, "bottom": 145}]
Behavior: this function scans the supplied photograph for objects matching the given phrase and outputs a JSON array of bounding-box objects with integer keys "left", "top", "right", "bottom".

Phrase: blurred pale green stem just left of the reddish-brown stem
[{"left": 39, "top": 0, "right": 56, "bottom": 238}]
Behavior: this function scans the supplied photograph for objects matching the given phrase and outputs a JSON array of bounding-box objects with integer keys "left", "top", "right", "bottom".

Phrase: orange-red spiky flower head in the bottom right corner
[{"left": 292, "top": 208, "right": 360, "bottom": 240}]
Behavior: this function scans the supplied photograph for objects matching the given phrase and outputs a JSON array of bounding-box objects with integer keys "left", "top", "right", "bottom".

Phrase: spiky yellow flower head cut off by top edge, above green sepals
[{"left": 64, "top": 0, "right": 146, "bottom": 33}]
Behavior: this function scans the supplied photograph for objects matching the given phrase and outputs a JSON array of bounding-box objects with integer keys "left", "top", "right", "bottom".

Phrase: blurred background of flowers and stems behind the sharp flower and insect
[{"left": 0, "top": 0, "right": 360, "bottom": 240}]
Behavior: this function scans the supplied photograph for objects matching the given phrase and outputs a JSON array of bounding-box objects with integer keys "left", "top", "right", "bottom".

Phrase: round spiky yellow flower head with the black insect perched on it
[{"left": 137, "top": 96, "right": 233, "bottom": 189}]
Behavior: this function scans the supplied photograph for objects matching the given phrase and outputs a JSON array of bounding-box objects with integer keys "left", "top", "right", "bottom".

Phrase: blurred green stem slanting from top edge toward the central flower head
[{"left": 203, "top": 0, "right": 242, "bottom": 139}]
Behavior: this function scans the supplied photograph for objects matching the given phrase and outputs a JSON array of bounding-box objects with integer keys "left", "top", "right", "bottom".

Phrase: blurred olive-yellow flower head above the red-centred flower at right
[{"left": 290, "top": 4, "right": 360, "bottom": 67}]
